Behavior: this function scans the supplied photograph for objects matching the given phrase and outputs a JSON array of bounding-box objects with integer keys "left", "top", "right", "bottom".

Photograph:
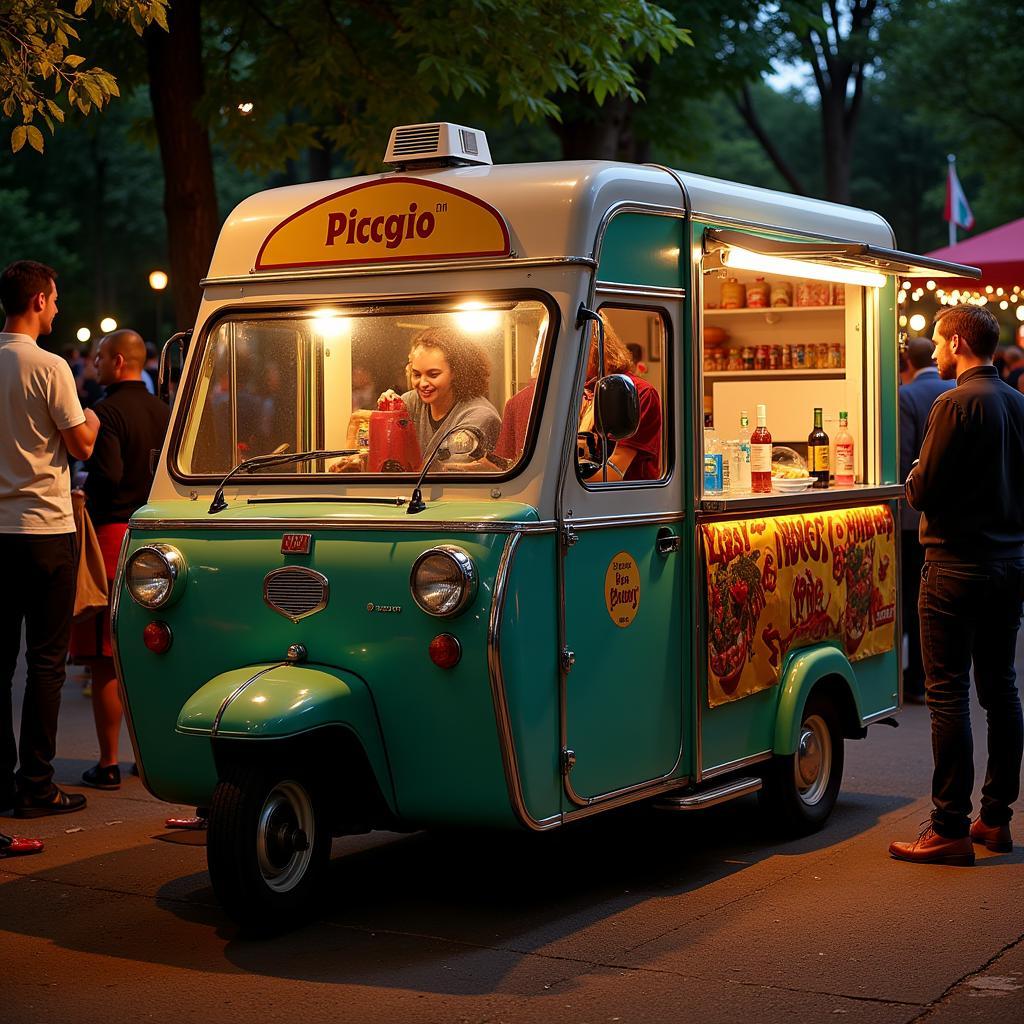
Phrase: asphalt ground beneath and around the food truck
[{"left": 0, "top": 638, "right": 1024, "bottom": 1024}]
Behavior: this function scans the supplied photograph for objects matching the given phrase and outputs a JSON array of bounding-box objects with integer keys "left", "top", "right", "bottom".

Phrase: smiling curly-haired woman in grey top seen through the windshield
[{"left": 380, "top": 328, "right": 502, "bottom": 469}]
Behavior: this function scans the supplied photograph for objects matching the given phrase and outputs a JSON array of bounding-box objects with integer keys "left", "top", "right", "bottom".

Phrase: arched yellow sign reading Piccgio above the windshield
[{"left": 256, "top": 177, "right": 511, "bottom": 270}]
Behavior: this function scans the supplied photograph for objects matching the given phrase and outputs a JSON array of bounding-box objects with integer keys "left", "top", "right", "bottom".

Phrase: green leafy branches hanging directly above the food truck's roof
[{"left": 205, "top": 0, "right": 690, "bottom": 172}]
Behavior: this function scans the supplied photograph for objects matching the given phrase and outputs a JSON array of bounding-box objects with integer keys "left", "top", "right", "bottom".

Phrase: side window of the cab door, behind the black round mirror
[{"left": 577, "top": 305, "right": 671, "bottom": 486}]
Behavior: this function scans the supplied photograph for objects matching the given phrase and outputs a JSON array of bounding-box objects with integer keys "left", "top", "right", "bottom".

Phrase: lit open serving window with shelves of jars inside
[{"left": 699, "top": 232, "right": 885, "bottom": 499}]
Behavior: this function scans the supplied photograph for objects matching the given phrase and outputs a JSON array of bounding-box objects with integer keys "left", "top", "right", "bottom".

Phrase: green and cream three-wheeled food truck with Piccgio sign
[{"left": 113, "top": 123, "right": 975, "bottom": 928}]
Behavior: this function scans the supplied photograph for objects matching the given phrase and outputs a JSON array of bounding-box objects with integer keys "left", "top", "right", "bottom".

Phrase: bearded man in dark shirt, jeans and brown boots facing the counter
[{"left": 889, "top": 306, "right": 1024, "bottom": 864}]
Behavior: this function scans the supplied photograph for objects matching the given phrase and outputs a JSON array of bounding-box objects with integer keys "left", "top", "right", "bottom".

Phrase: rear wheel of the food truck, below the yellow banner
[{"left": 758, "top": 693, "right": 844, "bottom": 836}]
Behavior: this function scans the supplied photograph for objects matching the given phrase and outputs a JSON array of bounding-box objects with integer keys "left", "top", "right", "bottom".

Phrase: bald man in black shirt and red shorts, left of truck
[{"left": 72, "top": 331, "right": 170, "bottom": 790}]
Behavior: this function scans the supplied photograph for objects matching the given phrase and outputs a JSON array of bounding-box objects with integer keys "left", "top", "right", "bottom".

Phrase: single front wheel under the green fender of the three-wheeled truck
[{"left": 206, "top": 764, "right": 331, "bottom": 934}]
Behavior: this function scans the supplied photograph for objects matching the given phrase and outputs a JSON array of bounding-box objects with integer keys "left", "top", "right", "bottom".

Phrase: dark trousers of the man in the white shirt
[{"left": 0, "top": 534, "right": 78, "bottom": 797}]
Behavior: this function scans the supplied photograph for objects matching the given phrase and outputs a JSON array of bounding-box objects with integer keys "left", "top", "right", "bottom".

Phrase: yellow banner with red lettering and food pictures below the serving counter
[{"left": 700, "top": 505, "right": 896, "bottom": 708}]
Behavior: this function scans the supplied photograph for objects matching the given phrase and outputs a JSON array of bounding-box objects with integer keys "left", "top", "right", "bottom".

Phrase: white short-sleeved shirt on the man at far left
[{"left": 0, "top": 332, "right": 85, "bottom": 534}]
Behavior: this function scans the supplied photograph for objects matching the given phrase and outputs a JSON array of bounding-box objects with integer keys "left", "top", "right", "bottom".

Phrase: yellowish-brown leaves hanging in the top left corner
[{"left": 0, "top": 0, "right": 168, "bottom": 153}]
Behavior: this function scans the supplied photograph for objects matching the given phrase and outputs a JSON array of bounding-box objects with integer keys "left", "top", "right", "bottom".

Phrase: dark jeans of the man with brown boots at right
[{"left": 919, "top": 560, "right": 1024, "bottom": 839}]
